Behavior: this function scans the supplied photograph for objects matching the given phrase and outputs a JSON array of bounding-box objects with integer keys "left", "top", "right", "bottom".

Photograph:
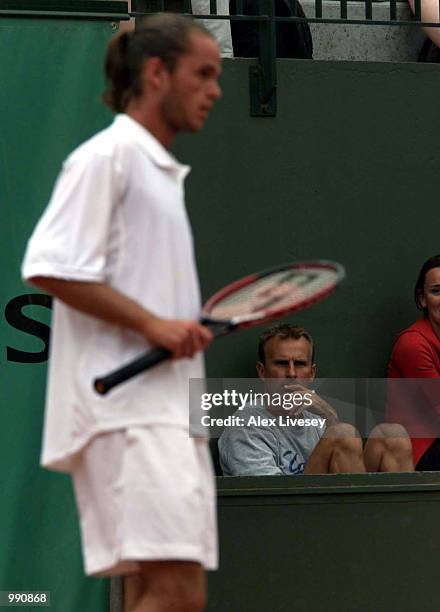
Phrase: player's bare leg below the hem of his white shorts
[{"left": 124, "top": 561, "right": 206, "bottom": 612}]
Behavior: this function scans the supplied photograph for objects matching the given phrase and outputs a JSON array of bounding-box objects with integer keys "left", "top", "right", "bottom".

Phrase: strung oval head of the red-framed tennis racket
[{"left": 202, "top": 260, "right": 345, "bottom": 330}]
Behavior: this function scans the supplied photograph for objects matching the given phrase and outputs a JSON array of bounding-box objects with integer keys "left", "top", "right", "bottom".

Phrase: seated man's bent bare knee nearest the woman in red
[{"left": 364, "top": 423, "right": 414, "bottom": 472}]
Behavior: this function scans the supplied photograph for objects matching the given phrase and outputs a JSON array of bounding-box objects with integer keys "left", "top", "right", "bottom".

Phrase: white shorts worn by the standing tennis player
[{"left": 72, "top": 425, "right": 218, "bottom": 576}]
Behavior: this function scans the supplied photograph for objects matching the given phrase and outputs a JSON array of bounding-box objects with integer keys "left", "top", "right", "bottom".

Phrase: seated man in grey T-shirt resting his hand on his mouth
[{"left": 219, "top": 324, "right": 414, "bottom": 476}]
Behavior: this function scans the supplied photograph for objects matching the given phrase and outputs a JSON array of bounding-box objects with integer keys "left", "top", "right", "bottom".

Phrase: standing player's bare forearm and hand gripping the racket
[{"left": 28, "top": 276, "right": 213, "bottom": 358}]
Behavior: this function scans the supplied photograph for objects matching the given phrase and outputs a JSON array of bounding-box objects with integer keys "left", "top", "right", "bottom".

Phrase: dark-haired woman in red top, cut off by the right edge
[{"left": 388, "top": 255, "right": 440, "bottom": 471}]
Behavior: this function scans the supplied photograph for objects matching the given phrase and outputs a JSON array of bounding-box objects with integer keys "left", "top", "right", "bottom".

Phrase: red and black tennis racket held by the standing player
[{"left": 93, "top": 261, "right": 345, "bottom": 395}]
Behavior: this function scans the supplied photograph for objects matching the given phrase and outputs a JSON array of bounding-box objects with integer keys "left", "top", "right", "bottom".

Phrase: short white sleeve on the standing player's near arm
[{"left": 22, "top": 154, "right": 118, "bottom": 281}]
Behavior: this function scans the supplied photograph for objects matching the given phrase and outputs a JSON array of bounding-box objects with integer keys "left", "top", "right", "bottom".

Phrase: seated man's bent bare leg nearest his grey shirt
[{"left": 304, "top": 423, "right": 365, "bottom": 474}]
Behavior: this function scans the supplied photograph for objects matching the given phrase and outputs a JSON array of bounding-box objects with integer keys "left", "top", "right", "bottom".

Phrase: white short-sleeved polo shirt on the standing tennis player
[{"left": 22, "top": 115, "right": 204, "bottom": 471}]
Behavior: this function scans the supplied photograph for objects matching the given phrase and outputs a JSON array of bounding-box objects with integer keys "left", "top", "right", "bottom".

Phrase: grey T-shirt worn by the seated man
[{"left": 218, "top": 406, "right": 325, "bottom": 476}]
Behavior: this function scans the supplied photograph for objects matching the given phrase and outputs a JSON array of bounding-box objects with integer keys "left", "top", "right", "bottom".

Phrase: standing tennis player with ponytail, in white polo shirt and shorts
[{"left": 22, "top": 14, "right": 221, "bottom": 612}]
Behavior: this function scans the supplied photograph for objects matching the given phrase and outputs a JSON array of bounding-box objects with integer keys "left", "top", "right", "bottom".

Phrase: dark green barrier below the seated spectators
[{"left": 207, "top": 473, "right": 440, "bottom": 612}]
